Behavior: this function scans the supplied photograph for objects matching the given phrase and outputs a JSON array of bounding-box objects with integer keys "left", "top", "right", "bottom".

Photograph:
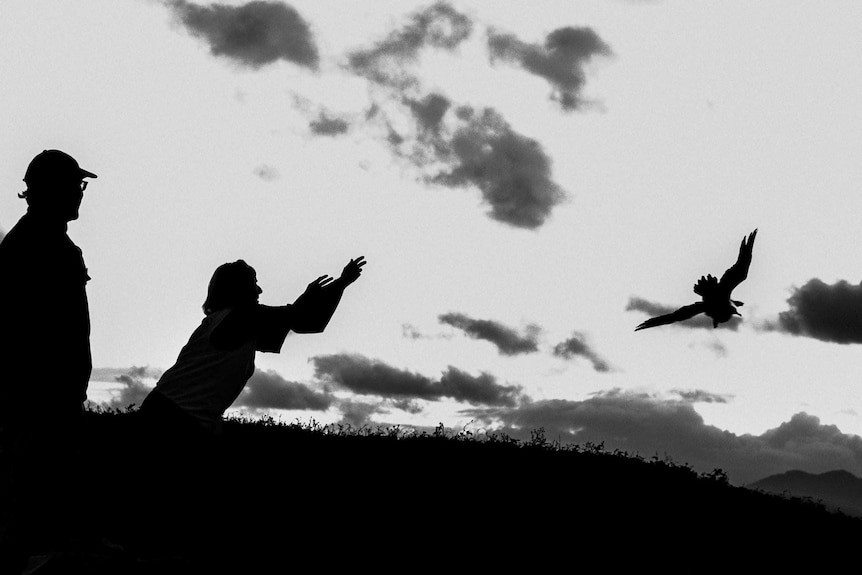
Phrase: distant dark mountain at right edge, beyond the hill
[{"left": 746, "top": 470, "right": 862, "bottom": 517}]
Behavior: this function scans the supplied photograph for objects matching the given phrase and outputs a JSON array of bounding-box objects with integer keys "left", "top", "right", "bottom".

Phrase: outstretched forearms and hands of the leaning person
[{"left": 291, "top": 256, "right": 366, "bottom": 333}]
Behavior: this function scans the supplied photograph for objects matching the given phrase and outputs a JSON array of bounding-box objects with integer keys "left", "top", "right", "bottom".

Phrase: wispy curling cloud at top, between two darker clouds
[{"left": 347, "top": 2, "right": 473, "bottom": 89}]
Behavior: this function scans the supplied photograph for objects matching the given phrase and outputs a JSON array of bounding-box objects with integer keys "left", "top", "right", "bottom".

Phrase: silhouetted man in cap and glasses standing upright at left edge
[{"left": 0, "top": 150, "right": 96, "bottom": 570}]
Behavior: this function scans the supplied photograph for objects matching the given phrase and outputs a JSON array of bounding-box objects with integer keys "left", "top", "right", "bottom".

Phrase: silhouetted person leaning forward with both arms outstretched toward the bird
[{"left": 140, "top": 256, "right": 366, "bottom": 436}]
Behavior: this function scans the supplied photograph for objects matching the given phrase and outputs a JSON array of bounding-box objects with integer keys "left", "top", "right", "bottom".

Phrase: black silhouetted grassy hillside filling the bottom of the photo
[{"left": 44, "top": 413, "right": 862, "bottom": 573}]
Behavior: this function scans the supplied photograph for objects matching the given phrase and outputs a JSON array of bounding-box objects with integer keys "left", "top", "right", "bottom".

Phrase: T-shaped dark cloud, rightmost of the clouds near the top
[{"left": 488, "top": 27, "right": 611, "bottom": 111}]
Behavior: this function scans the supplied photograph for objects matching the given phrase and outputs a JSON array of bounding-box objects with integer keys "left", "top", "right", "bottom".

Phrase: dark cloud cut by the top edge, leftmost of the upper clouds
[{"left": 166, "top": 0, "right": 320, "bottom": 70}]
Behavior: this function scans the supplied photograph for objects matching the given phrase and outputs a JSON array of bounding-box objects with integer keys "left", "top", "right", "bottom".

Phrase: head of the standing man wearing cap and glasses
[{"left": 19, "top": 150, "right": 97, "bottom": 222}]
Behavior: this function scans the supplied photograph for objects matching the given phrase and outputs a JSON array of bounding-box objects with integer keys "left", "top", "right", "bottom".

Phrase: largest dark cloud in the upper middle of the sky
[{"left": 420, "top": 106, "right": 566, "bottom": 229}]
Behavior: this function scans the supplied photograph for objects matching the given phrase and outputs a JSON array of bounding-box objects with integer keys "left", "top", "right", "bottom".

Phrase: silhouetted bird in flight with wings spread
[{"left": 635, "top": 229, "right": 757, "bottom": 331}]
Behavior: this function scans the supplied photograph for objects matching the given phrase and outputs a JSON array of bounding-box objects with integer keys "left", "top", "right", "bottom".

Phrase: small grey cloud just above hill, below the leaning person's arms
[{"left": 238, "top": 369, "right": 334, "bottom": 411}]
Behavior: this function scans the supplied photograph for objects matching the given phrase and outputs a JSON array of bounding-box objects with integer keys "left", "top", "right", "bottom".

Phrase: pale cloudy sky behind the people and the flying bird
[{"left": 5, "top": 0, "right": 862, "bottom": 483}]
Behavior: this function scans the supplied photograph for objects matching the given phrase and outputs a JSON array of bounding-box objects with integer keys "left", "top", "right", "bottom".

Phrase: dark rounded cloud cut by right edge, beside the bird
[{"left": 763, "top": 278, "right": 862, "bottom": 344}]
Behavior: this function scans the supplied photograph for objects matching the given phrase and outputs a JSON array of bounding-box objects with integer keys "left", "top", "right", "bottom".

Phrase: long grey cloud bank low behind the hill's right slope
[{"left": 464, "top": 390, "right": 862, "bottom": 484}]
